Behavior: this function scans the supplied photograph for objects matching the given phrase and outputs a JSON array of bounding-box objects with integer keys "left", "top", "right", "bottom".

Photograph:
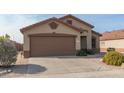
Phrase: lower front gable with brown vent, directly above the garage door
[{"left": 22, "top": 20, "right": 79, "bottom": 35}]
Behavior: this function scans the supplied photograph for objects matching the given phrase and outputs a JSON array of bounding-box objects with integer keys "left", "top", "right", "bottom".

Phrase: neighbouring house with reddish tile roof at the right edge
[{"left": 100, "top": 30, "right": 124, "bottom": 52}]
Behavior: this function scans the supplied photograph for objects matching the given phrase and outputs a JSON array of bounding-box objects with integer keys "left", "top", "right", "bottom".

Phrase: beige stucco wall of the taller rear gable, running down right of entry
[{"left": 63, "top": 18, "right": 92, "bottom": 49}]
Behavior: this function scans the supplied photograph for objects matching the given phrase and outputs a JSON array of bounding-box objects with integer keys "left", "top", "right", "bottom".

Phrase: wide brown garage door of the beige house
[{"left": 30, "top": 36, "right": 75, "bottom": 57}]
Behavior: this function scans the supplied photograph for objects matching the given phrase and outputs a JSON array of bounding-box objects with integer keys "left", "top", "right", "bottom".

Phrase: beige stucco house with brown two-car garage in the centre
[{"left": 21, "top": 15, "right": 101, "bottom": 58}]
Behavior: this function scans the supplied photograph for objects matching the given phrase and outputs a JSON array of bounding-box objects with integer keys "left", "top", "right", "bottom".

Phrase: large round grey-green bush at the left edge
[{"left": 0, "top": 36, "right": 17, "bottom": 67}]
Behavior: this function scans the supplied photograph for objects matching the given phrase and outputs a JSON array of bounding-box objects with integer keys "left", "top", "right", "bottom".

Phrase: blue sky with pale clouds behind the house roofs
[{"left": 0, "top": 14, "right": 124, "bottom": 43}]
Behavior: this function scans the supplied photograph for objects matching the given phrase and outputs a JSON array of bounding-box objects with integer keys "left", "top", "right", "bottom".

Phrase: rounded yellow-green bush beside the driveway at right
[{"left": 103, "top": 51, "right": 123, "bottom": 66}]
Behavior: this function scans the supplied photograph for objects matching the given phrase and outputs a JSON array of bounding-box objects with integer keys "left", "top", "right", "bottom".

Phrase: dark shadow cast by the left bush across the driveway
[{"left": 0, "top": 64, "right": 47, "bottom": 75}]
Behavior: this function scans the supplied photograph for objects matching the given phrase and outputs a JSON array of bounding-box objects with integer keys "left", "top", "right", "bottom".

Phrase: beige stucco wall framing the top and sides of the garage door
[{"left": 24, "top": 22, "right": 87, "bottom": 51}]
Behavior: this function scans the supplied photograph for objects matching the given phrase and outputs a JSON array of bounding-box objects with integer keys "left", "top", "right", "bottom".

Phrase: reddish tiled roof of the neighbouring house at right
[{"left": 100, "top": 29, "right": 124, "bottom": 40}]
